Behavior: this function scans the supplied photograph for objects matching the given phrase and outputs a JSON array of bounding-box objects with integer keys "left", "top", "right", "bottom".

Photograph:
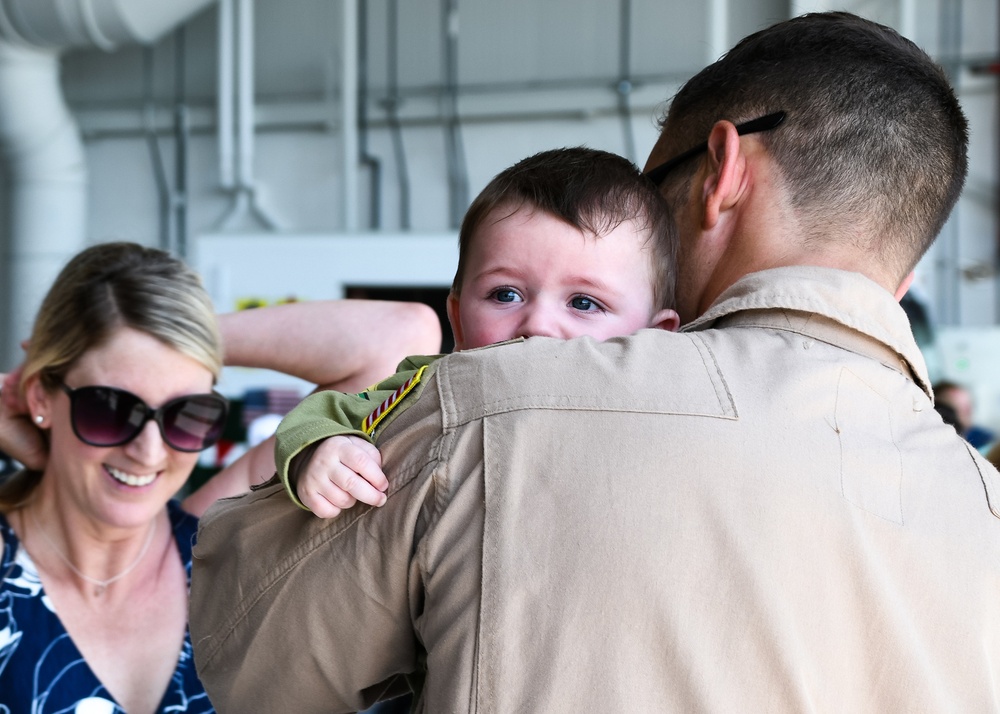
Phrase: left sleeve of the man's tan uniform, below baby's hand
[{"left": 190, "top": 362, "right": 443, "bottom": 714}]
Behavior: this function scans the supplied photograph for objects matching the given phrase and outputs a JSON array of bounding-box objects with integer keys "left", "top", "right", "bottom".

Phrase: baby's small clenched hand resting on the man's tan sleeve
[{"left": 295, "top": 436, "right": 389, "bottom": 518}]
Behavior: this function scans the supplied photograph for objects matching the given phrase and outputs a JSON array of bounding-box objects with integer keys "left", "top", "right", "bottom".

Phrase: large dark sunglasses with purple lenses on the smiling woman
[{"left": 61, "top": 384, "right": 229, "bottom": 452}]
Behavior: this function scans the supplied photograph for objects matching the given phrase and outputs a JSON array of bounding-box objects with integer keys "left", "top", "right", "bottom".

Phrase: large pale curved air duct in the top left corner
[{"left": 0, "top": 0, "right": 213, "bottom": 364}]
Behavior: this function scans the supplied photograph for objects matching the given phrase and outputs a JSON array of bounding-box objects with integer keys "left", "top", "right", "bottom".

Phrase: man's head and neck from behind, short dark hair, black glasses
[{"left": 647, "top": 13, "right": 968, "bottom": 322}]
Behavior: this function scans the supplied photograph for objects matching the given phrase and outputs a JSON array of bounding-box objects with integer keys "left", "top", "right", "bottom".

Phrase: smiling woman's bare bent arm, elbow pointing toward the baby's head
[{"left": 184, "top": 300, "right": 441, "bottom": 515}]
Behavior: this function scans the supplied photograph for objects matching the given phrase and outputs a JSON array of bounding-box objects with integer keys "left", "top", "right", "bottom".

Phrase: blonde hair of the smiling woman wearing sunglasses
[{"left": 0, "top": 243, "right": 222, "bottom": 510}]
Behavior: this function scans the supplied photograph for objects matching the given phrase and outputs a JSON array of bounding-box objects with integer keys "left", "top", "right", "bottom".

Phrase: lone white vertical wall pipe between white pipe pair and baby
[{"left": 340, "top": 0, "right": 359, "bottom": 233}]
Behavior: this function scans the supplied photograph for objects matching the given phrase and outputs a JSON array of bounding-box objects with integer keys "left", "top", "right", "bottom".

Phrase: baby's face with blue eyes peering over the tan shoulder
[{"left": 448, "top": 207, "right": 678, "bottom": 350}]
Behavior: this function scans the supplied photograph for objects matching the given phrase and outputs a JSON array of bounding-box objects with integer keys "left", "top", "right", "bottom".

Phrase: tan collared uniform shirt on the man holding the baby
[{"left": 191, "top": 268, "right": 1000, "bottom": 713}]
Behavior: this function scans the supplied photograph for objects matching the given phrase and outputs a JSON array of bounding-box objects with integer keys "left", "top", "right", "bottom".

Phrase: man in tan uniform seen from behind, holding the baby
[{"left": 191, "top": 13, "right": 1000, "bottom": 712}]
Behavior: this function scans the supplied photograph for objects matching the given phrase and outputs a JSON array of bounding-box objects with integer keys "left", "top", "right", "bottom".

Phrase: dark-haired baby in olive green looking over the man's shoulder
[{"left": 276, "top": 148, "right": 679, "bottom": 518}]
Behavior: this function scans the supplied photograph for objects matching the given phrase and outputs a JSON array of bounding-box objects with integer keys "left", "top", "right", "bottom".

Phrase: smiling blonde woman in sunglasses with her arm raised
[{"left": 0, "top": 243, "right": 440, "bottom": 714}]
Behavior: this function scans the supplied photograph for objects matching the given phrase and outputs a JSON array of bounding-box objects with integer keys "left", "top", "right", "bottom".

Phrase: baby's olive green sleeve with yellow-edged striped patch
[{"left": 274, "top": 355, "right": 438, "bottom": 510}]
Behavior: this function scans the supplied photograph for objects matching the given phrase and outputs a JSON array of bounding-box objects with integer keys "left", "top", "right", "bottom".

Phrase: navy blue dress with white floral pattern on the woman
[{"left": 0, "top": 501, "right": 215, "bottom": 714}]
